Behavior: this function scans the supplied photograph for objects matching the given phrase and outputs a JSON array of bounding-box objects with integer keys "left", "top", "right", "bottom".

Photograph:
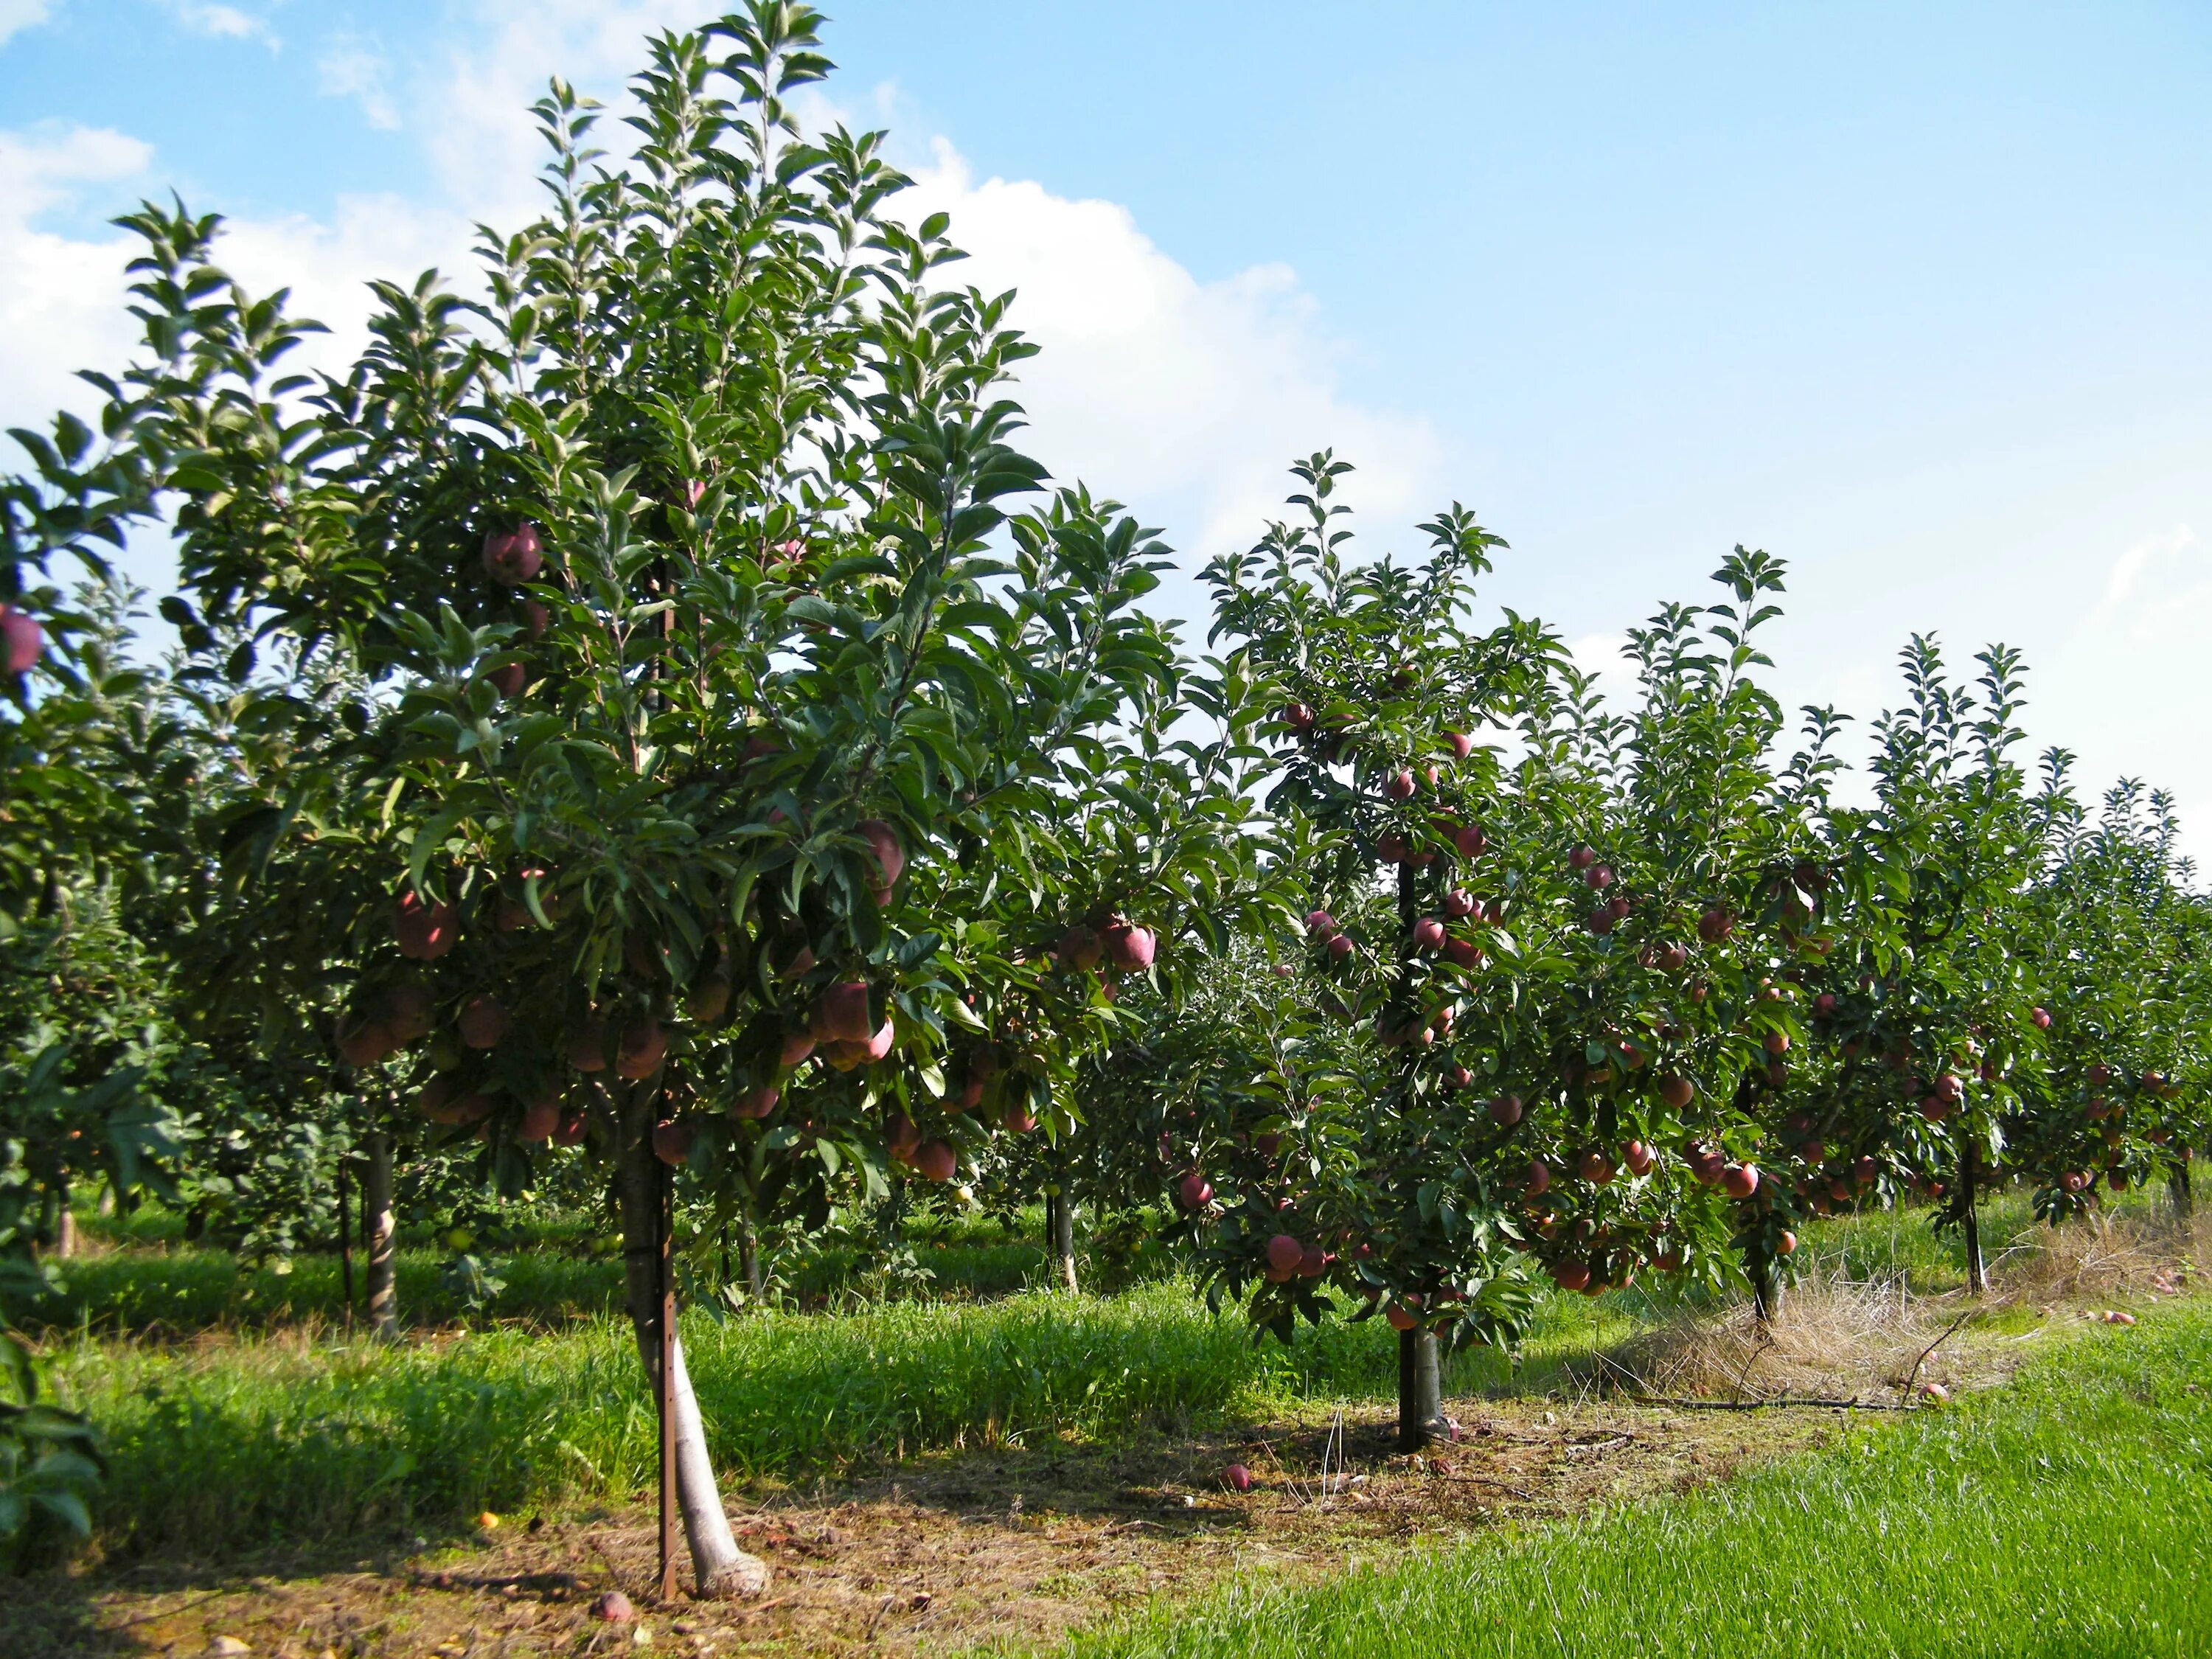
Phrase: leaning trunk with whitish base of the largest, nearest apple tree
[{"left": 615, "top": 1088, "right": 768, "bottom": 1597}]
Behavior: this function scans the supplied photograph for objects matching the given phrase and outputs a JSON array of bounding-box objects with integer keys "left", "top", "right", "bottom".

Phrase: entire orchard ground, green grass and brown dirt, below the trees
[{"left": 0, "top": 1197, "right": 2212, "bottom": 1659}]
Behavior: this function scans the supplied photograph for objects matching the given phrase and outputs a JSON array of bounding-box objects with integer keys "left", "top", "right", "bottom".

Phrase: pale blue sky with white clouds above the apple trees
[{"left": 0, "top": 0, "right": 2212, "bottom": 847}]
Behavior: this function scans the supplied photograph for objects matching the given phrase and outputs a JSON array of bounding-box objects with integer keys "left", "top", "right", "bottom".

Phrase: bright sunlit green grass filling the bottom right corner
[{"left": 1071, "top": 1305, "right": 2212, "bottom": 1659}]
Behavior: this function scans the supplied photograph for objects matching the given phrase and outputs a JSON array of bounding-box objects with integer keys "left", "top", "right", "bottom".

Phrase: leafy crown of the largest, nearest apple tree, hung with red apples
[{"left": 73, "top": 0, "right": 1252, "bottom": 1586}]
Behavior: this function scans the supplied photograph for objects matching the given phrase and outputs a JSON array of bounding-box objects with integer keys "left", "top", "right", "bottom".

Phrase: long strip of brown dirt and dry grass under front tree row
[{"left": 0, "top": 1219, "right": 2212, "bottom": 1659}]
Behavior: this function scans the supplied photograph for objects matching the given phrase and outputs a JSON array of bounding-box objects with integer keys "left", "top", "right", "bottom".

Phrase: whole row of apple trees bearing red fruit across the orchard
[{"left": 0, "top": 0, "right": 2205, "bottom": 1593}]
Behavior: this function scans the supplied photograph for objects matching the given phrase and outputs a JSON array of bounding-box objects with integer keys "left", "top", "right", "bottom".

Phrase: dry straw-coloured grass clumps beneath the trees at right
[{"left": 1575, "top": 1210, "right": 2212, "bottom": 1405}]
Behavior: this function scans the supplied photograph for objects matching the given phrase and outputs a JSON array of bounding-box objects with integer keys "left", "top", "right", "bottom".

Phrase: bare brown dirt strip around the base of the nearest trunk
[{"left": 0, "top": 1400, "right": 1847, "bottom": 1659}]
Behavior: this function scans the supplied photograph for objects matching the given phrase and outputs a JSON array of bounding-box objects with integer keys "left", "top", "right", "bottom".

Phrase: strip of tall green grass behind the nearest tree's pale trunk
[{"left": 55, "top": 1283, "right": 1396, "bottom": 1557}]
